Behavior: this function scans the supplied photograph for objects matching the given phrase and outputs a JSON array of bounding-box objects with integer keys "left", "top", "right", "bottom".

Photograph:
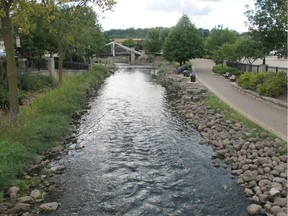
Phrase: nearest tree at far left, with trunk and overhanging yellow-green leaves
[{"left": 0, "top": 0, "right": 116, "bottom": 122}]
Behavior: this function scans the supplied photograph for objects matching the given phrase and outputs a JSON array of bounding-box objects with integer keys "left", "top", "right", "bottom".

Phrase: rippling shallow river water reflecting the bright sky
[{"left": 44, "top": 65, "right": 249, "bottom": 216}]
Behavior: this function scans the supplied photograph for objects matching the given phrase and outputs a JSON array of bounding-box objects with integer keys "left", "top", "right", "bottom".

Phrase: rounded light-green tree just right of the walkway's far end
[{"left": 205, "top": 27, "right": 237, "bottom": 55}]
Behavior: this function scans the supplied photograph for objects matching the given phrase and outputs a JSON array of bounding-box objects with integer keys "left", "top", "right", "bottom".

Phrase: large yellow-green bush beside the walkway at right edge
[{"left": 237, "top": 72, "right": 287, "bottom": 97}]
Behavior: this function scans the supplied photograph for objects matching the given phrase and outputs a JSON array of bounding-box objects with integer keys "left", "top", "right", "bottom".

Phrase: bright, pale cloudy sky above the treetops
[{"left": 99, "top": 0, "right": 255, "bottom": 33}]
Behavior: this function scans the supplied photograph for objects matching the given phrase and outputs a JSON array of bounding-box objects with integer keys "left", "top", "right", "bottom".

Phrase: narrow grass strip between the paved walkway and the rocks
[{"left": 204, "top": 94, "right": 287, "bottom": 155}]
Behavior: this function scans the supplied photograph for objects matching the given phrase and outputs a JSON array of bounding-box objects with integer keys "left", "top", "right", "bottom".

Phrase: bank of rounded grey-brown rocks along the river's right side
[{"left": 158, "top": 72, "right": 287, "bottom": 216}]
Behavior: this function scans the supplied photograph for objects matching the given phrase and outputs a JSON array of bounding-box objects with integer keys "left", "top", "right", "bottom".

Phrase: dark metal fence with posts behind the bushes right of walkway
[{"left": 227, "top": 62, "right": 288, "bottom": 74}]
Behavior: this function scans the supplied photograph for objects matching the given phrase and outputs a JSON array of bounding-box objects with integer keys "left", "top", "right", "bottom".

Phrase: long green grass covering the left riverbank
[{"left": 0, "top": 66, "right": 108, "bottom": 199}]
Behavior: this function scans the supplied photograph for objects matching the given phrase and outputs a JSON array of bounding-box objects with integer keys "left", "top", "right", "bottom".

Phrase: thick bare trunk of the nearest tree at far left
[{"left": 1, "top": 12, "right": 19, "bottom": 123}]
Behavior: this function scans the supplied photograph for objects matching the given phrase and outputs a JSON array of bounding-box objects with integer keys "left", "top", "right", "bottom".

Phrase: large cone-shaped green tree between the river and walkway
[{"left": 163, "top": 15, "right": 203, "bottom": 65}]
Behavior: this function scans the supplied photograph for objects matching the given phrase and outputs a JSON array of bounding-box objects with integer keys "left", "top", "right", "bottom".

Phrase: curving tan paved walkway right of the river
[{"left": 192, "top": 59, "right": 287, "bottom": 141}]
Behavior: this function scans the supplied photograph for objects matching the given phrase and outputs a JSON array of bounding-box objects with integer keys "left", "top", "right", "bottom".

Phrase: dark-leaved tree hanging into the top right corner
[{"left": 245, "top": 0, "right": 288, "bottom": 56}]
